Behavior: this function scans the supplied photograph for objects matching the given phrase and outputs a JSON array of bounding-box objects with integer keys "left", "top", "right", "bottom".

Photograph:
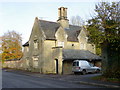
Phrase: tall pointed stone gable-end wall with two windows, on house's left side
[{"left": 28, "top": 18, "right": 45, "bottom": 73}]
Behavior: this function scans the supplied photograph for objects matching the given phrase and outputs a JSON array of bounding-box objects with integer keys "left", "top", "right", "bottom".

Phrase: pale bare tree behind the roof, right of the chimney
[{"left": 70, "top": 16, "right": 85, "bottom": 26}]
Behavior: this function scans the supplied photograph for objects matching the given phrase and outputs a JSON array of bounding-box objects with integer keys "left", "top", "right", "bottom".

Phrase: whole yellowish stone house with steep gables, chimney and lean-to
[{"left": 22, "top": 7, "right": 101, "bottom": 74}]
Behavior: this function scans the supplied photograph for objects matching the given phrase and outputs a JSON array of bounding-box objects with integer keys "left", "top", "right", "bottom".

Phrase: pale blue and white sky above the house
[{"left": 0, "top": 0, "right": 116, "bottom": 44}]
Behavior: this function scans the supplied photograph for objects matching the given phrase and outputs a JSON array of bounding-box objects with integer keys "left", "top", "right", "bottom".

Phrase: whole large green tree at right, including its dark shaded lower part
[{"left": 87, "top": 2, "right": 120, "bottom": 77}]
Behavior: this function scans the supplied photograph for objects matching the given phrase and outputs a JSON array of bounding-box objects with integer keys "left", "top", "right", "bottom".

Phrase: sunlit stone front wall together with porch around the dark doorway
[{"left": 43, "top": 40, "right": 62, "bottom": 74}]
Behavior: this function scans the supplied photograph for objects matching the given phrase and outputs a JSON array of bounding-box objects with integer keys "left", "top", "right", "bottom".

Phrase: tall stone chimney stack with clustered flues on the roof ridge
[{"left": 57, "top": 7, "right": 69, "bottom": 28}]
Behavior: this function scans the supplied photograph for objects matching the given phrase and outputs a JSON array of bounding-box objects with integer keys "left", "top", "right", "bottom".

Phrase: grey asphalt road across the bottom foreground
[{"left": 2, "top": 71, "right": 103, "bottom": 88}]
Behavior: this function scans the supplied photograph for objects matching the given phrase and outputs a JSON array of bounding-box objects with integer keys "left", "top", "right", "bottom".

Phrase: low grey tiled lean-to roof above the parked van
[{"left": 63, "top": 49, "right": 101, "bottom": 60}]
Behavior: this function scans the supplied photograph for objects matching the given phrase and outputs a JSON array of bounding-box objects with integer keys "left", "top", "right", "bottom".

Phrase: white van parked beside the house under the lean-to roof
[{"left": 72, "top": 60, "right": 101, "bottom": 74}]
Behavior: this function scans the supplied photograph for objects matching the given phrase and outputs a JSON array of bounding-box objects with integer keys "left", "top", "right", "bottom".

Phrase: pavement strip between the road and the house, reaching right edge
[{"left": 4, "top": 69, "right": 120, "bottom": 88}]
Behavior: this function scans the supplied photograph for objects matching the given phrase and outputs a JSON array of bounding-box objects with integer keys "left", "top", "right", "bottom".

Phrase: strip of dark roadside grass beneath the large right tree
[{"left": 91, "top": 75, "right": 120, "bottom": 83}]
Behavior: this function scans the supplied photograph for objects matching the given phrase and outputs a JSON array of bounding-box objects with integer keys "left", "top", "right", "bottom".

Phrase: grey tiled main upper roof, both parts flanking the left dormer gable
[{"left": 39, "top": 20, "right": 81, "bottom": 41}]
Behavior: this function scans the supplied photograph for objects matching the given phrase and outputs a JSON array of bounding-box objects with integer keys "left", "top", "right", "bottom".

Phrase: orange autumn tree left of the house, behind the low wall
[{"left": 1, "top": 31, "right": 22, "bottom": 61}]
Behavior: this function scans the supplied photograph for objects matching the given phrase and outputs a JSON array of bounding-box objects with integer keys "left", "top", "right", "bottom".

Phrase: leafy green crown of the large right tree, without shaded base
[{"left": 88, "top": 2, "right": 120, "bottom": 44}]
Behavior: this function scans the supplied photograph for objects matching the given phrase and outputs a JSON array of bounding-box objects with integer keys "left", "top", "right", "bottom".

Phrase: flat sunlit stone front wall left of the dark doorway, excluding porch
[{"left": 43, "top": 40, "right": 55, "bottom": 73}]
